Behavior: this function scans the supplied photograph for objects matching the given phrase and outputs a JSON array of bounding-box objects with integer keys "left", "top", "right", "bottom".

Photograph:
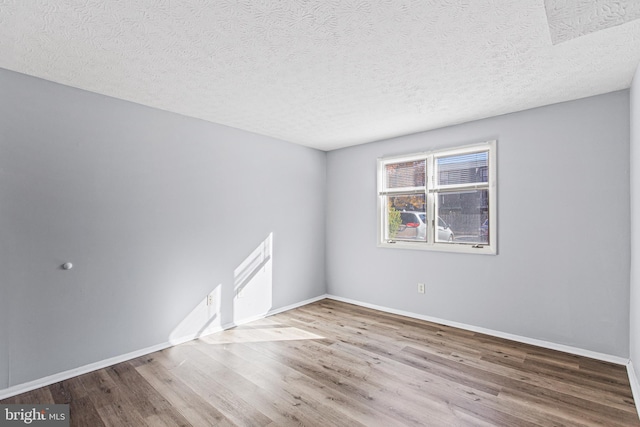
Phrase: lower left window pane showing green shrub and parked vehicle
[{"left": 385, "top": 194, "right": 427, "bottom": 241}]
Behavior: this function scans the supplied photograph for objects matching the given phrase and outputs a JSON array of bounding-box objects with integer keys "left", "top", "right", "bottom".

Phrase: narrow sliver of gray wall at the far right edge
[{"left": 629, "top": 61, "right": 640, "bottom": 381}]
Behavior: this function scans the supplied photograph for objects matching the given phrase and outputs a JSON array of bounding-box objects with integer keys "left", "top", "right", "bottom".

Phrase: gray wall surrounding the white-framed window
[{"left": 327, "top": 91, "right": 630, "bottom": 357}]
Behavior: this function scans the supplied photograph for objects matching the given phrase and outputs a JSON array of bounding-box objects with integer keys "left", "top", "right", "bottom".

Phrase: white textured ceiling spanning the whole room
[{"left": 0, "top": 0, "right": 640, "bottom": 150}]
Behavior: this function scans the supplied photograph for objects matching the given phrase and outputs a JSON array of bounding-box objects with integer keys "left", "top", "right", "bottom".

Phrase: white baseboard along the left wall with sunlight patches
[{"left": 0, "top": 294, "right": 328, "bottom": 400}]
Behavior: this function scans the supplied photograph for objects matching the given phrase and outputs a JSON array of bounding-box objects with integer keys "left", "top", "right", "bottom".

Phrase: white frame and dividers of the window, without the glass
[{"left": 377, "top": 140, "right": 498, "bottom": 255}]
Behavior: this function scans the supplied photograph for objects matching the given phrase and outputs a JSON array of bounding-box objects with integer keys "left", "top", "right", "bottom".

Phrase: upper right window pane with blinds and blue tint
[{"left": 437, "top": 151, "right": 489, "bottom": 185}]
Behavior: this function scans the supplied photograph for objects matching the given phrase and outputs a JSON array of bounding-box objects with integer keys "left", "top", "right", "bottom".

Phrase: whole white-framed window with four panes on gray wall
[{"left": 378, "top": 141, "right": 497, "bottom": 254}]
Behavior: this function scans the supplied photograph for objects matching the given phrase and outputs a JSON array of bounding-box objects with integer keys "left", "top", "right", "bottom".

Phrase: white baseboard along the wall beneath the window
[{"left": 327, "top": 295, "right": 629, "bottom": 365}]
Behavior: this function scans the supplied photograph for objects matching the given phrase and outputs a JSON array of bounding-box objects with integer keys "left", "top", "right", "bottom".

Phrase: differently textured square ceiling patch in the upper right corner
[{"left": 544, "top": 0, "right": 640, "bottom": 43}]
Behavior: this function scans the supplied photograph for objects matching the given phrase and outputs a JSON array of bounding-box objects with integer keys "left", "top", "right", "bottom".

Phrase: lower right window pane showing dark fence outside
[{"left": 436, "top": 190, "right": 489, "bottom": 244}]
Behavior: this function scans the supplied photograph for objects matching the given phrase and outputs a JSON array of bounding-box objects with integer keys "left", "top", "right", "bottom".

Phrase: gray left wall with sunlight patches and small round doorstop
[{"left": 0, "top": 70, "right": 326, "bottom": 390}]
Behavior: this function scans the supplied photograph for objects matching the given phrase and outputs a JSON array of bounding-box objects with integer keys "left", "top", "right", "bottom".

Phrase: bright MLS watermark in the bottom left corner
[{"left": 0, "top": 405, "right": 69, "bottom": 427}]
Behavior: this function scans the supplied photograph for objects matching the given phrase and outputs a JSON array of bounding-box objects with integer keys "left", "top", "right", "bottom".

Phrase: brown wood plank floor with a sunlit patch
[{"left": 0, "top": 300, "right": 640, "bottom": 427}]
